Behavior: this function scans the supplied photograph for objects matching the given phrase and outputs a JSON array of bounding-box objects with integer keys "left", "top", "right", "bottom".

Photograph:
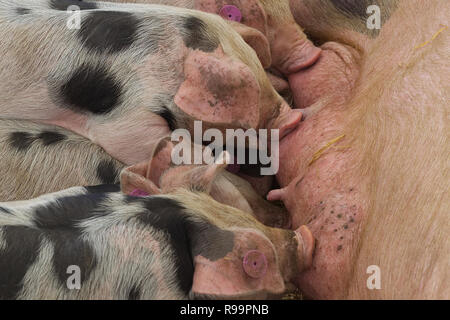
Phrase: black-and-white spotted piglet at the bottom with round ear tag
[{"left": 0, "top": 186, "right": 314, "bottom": 299}]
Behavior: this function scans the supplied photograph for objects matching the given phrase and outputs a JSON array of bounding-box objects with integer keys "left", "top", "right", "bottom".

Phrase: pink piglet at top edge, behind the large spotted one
[{"left": 100, "top": 0, "right": 321, "bottom": 86}]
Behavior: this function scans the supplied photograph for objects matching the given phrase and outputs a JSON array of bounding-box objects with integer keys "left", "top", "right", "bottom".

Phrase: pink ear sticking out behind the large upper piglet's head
[{"left": 229, "top": 21, "right": 272, "bottom": 69}]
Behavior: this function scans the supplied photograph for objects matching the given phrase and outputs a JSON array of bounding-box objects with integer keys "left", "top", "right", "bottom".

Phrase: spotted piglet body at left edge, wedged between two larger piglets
[{"left": 0, "top": 119, "right": 124, "bottom": 202}]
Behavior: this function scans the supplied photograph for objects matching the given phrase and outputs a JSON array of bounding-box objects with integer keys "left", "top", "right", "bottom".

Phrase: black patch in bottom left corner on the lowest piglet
[{"left": 0, "top": 226, "right": 41, "bottom": 300}]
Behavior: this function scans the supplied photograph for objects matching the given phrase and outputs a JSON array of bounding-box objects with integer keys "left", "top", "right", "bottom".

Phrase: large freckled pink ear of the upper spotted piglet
[{"left": 174, "top": 46, "right": 261, "bottom": 128}]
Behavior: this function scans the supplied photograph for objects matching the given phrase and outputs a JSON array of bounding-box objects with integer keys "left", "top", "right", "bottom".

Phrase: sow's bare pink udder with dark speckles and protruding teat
[{"left": 268, "top": 11, "right": 366, "bottom": 299}]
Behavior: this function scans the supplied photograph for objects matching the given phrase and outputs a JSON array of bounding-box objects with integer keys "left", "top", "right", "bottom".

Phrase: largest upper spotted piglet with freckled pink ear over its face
[{"left": 0, "top": 0, "right": 301, "bottom": 165}]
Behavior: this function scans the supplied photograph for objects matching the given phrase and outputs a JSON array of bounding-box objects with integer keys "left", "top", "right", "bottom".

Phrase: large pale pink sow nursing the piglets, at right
[{"left": 268, "top": 0, "right": 449, "bottom": 299}]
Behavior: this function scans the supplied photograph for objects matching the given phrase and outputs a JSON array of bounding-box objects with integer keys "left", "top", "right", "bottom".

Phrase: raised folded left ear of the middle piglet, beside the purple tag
[{"left": 120, "top": 137, "right": 173, "bottom": 195}]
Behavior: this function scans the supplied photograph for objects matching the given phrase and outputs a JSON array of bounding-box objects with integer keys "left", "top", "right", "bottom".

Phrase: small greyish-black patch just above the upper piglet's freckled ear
[{"left": 182, "top": 17, "right": 219, "bottom": 52}]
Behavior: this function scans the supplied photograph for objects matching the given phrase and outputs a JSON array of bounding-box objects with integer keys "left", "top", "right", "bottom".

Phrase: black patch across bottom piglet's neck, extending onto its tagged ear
[{"left": 135, "top": 197, "right": 234, "bottom": 294}]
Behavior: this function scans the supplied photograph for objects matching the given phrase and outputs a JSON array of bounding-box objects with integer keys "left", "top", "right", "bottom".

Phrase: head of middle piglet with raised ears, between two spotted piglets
[{"left": 120, "top": 138, "right": 290, "bottom": 229}]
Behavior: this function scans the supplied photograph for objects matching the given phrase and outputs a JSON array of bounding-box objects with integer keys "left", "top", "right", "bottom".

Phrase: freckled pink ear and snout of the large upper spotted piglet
[{"left": 174, "top": 47, "right": 303, "bottom": 137}]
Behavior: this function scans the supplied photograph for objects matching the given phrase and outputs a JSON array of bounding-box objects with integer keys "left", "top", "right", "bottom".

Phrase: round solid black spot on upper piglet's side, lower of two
[{"left": 58, "top": 65, "right": 122, "bottom": 114}]
